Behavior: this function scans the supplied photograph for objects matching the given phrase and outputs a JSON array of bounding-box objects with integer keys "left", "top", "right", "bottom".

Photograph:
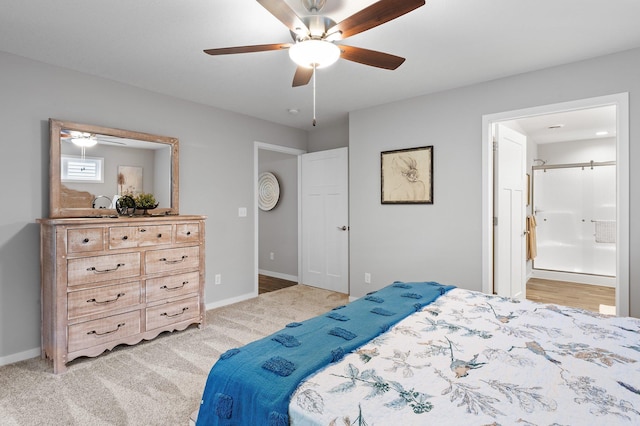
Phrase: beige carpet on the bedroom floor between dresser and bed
[{"left": 0, "top": 285, "right": 347, "bottom": 426}]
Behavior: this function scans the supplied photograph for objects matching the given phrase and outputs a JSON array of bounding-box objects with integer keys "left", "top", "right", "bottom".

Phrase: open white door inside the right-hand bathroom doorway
[{"left": 494, "top": 124, "right": 527, "bottom": 299}]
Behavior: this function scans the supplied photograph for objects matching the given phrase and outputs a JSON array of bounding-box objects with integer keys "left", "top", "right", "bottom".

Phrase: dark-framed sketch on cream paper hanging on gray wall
[{"left": 380, "top": 145, "right": 433, "bottom": 204}]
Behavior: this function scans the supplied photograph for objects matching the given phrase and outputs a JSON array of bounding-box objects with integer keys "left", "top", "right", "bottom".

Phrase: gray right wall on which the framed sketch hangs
[{"left": 349, "top": 49, "right": 640, "bottom": 316}]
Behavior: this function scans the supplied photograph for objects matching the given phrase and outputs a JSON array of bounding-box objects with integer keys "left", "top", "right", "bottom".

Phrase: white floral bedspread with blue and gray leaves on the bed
[{"left": 289, "top": 289, "right": 640, "bottom": 426}]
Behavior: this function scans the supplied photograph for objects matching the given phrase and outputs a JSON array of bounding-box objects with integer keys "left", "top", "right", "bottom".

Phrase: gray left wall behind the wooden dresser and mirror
[{"left": 0, "top": 52, "right": 307, "bottom": 364}]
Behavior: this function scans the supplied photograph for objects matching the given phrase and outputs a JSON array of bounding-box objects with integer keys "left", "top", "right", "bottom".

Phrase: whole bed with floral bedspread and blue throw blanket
[{"left": 197, "top": 282, "right": 640, "bottom": 425}]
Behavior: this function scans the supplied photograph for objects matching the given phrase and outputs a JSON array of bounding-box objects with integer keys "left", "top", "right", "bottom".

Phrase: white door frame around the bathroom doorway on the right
[{"left": 482, "top": 92, "right": 630, "bottom": 316}]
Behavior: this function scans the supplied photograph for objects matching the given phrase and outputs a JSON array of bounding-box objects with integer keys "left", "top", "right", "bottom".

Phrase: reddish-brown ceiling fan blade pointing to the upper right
[{"left": 327, "top": 0, "right": 425, "bottom": 39}]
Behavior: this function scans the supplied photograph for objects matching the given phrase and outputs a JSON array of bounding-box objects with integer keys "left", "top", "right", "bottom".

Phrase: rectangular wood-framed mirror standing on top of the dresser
[{"left": 49, "top": 119, "right": 179, "bottom": 217}]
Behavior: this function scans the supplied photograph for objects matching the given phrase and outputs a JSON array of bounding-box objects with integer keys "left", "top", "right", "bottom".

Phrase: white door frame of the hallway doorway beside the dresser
[{"left": 253, "top": 142, "right": 307, "bottom": 295}]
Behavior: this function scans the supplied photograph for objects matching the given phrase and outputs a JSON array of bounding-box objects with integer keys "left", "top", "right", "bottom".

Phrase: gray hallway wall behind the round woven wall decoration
[{"left": 258, "top": 149, "right": 298, "bottom": 281}]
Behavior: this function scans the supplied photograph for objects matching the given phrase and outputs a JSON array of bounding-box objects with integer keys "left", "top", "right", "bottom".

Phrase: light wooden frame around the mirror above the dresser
[{"left": 49, "top": 118, "right": 180, "bottom": 218}]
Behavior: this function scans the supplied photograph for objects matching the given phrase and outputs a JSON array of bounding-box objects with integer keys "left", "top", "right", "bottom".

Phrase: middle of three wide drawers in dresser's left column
[{"left": 67, "top": 281, "right": 140, "bottom": 319}]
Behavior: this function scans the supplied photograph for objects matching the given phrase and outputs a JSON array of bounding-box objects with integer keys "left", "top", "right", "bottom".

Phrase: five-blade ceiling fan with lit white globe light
[{"left": 204, "top": 0, "right": 425, "bottom": 87}]
